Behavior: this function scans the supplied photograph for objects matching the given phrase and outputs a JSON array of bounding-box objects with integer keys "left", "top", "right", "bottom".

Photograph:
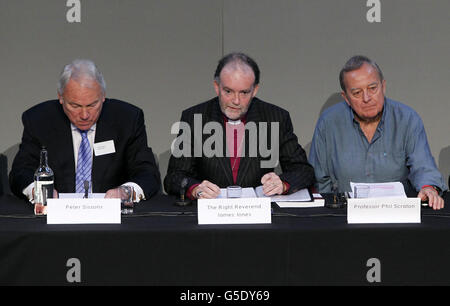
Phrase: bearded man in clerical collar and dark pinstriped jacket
[{"left": 164, "top": 53, "right": 314, "bottom": 199}]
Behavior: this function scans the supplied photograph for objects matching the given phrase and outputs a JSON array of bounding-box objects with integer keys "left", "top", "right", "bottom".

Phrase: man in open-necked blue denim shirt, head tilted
[{"left": 309, "top": 56, "right": 447, "bottom": 209}]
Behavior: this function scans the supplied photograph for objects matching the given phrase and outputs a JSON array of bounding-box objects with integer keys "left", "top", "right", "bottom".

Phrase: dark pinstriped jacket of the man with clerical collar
[{"left": 164, "top": 97, "right": 314, "bottom": 195}]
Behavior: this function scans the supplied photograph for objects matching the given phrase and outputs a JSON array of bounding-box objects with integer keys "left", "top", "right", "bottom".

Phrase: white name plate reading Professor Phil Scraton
[{"left": 347, "top": 197, "right": 421, "bottom": 224}]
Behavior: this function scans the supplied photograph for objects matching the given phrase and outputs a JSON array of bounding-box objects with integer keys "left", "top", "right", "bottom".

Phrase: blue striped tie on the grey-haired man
[{"left": 75, "top": 130, "right": 92, "bottom": 193}]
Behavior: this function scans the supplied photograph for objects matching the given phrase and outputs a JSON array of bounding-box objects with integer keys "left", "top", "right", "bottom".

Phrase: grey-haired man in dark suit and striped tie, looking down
[{"left": 9, "top": 60, "right": 161, "bottom": 201}]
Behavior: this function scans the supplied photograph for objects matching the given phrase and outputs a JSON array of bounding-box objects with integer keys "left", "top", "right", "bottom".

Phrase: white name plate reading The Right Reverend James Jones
[{"left": 197, "top": 198, "right": 272, "bottom": 224}]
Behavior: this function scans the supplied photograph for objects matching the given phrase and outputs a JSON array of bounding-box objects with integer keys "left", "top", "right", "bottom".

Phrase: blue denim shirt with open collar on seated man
[{"left": 309, "top": 98, "right": 447, "bottom": 194}]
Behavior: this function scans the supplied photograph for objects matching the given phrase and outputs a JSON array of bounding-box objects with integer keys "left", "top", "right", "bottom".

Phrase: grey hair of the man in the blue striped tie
[{"left": 58, "top": 59, "right": 106, "bottom": 95}]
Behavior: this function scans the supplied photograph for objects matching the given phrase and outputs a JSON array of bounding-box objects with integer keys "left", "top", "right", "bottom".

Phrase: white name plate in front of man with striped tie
[{"left": 47, "top": 199, "right": 121, "bottom": 224}]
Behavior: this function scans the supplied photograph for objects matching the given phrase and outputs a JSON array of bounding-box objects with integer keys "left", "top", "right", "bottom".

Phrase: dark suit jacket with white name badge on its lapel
[{"left": 9, "top": 99, "right": 161, "bottom": 199}]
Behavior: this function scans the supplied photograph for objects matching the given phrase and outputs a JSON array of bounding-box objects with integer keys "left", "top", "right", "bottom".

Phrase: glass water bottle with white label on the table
[{"left": 34, "top": 147, "right": 54, "bottom": 215}]
